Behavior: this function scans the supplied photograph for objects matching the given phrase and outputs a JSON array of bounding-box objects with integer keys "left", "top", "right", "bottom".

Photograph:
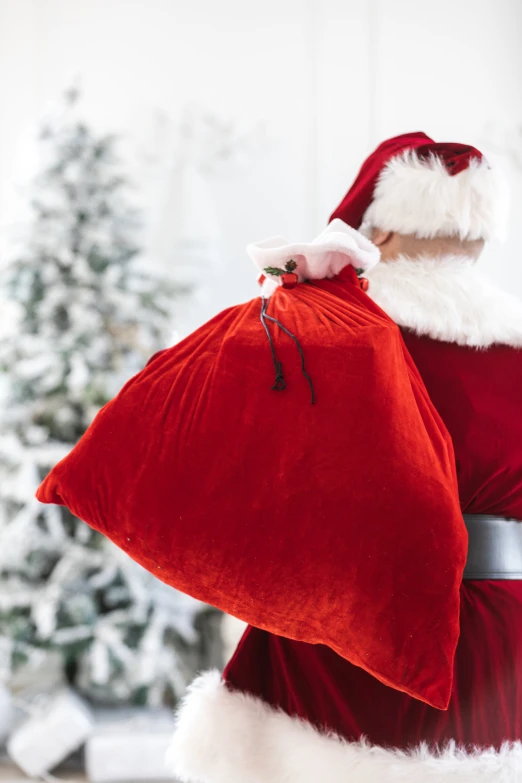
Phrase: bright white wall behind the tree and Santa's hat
[{"left": 0, "top": 0, "right": 522, "bottom": 322}]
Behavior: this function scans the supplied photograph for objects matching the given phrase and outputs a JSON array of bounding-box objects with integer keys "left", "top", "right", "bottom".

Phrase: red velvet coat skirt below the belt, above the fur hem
[{"left": 225, "top": 582, "right": 522, "bottom": 749}]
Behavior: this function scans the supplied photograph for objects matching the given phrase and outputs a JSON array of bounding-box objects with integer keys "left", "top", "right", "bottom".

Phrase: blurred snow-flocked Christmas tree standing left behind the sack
[{"left": 0, "top": 91, "right": 221, "bottom": 704}]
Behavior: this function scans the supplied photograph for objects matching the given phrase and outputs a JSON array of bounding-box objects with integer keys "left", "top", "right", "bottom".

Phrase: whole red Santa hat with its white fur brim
[{"left": 330, "top": 132, "right": 508, "bottom": 240}]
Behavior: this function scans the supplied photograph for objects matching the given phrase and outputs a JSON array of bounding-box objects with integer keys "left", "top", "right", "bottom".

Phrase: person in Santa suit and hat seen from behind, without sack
[{"left": 171, "top": 133, "right": 522, "bottom": 783}]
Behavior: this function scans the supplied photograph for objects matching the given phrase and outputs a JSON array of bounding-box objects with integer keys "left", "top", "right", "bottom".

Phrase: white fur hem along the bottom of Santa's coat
[{"left": 168, "top": 672, "right": 522, "bottom": 783}]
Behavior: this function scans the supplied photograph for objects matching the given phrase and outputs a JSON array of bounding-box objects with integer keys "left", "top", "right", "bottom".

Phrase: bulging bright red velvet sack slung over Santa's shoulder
[{"left": 38, "top": 225, "right": 466, "bottom": 708}]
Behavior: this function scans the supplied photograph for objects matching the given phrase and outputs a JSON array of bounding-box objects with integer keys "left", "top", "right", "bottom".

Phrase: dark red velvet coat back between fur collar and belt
[{"left": 403, "top": 331, "right": 522, "bottom": 520}]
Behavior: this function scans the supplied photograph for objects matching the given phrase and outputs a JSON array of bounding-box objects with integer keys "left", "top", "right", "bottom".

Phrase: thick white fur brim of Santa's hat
[{"left": 363, "top": 150, "right": 509, "bottom": 239}]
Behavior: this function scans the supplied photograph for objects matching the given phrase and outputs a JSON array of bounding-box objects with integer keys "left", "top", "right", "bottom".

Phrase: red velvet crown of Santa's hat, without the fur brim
[{"left": 330, "top": 132, "right": 483, "bottom": 228}]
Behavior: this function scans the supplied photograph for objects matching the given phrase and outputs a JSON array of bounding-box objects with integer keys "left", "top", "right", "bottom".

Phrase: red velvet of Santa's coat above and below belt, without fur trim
[{"left": 225, "top": 331, "right": 522, "bottom": 749}]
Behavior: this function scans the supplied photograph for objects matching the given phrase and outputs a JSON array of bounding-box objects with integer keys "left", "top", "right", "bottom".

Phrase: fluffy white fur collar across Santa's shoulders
[{"left": 368, "top": 256, "right": 522, "bottom": 348}]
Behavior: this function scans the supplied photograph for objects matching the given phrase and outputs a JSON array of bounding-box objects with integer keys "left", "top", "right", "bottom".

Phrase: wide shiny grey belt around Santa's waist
[{"left": 464, "top": 514, "right": 522, "bottom": 579}]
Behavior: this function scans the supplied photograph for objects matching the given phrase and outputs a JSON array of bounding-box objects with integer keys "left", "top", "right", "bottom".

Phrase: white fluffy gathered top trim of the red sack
[{"left": 247, "top": 219, "right": 380, "bottom": 296}]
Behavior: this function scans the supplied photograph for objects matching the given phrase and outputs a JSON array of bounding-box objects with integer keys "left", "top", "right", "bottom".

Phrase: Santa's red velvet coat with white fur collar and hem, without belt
[{"left": 173, "top": 259, "right": 522, "bottom": 783}]
